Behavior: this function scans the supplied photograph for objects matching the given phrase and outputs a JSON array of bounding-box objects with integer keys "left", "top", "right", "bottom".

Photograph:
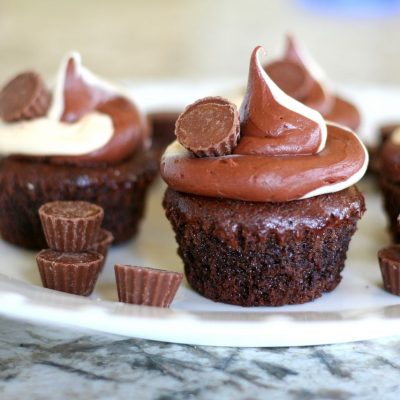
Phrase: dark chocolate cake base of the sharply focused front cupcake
[{"left": 164, "top": 187, "right": 365, "bottom": 306}]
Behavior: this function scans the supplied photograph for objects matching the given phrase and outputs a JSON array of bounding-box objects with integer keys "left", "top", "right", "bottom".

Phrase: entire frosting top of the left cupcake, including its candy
[{"left": 0, "top": 53, "right": 149, "bottom": 165}]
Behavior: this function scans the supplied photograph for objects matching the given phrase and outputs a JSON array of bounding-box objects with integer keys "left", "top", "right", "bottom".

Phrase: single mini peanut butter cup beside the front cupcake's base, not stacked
[{"left": 114, "top": 264, "right": 183, "bottom": 307}]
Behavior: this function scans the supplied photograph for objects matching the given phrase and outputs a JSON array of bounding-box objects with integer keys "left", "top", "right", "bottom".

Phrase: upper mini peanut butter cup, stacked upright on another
[{"left": 39, "top": 201, "right": 104, "bottom": 252}]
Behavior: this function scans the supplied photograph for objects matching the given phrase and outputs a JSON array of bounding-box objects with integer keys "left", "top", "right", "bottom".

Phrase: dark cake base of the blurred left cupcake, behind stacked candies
[{"left": 0, "top": 151, "right": 157, "bottom": 249}]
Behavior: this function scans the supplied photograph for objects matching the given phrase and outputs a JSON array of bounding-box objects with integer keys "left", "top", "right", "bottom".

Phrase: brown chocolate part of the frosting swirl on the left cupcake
[{"left": 49, "top": 57, "right": 149, "bottom": 164}]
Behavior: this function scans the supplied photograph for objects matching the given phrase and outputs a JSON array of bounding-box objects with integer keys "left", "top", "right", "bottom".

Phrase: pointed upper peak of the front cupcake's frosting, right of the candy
[{"left": 236, "top": 46, "right": 327, "bottom": 156}]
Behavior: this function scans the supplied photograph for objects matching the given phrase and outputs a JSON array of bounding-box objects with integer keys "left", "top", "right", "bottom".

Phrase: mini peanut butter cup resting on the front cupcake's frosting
[{"left": 175, "top": 97, "right": 240, "bottom": 157}]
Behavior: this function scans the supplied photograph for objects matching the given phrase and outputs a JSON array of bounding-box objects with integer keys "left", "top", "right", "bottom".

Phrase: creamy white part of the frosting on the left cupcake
[{"left": 0, "top": 52, "right": 122, "bottom": 156}]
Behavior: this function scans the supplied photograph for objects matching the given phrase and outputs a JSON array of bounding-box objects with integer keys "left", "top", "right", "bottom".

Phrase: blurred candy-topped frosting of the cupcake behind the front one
[{"left": 264, "top": 35, "right": 360, "bottom": 130}]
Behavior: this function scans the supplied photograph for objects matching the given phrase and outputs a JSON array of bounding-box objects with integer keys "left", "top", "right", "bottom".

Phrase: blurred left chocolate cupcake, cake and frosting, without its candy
[{"left": 0, "top": 54, "right": 157, "bottom": 248}]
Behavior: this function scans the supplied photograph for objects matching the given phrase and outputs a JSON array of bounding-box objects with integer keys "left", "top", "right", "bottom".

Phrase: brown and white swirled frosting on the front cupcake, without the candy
[{"left": 161, "top": 47, "right": 368, "bottom": 202}]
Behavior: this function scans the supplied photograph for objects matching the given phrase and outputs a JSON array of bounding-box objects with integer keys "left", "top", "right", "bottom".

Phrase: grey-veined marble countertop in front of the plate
[{"left": 0, "top": 317, "right": 400, "bottom": 400}]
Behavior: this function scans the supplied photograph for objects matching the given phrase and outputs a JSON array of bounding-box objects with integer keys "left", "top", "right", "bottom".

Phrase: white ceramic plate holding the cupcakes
[{"left": 0, "top": 85, "right": 400, "bottom": 346}]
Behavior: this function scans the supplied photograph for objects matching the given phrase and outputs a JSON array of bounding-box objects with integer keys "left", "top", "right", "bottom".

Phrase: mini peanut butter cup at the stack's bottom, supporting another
[{"left": 36, "top": 249, "right": 104, "bottom": 296}]
